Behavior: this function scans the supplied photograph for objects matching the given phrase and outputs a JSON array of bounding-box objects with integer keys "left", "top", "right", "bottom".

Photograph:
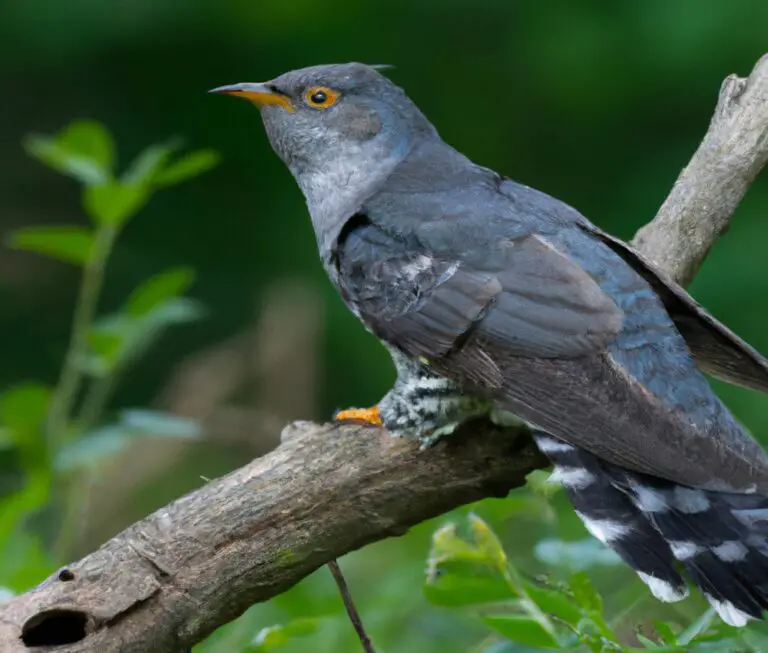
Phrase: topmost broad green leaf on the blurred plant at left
[{"left": 24, "top": 120, "right": 115, "bottom": 186}]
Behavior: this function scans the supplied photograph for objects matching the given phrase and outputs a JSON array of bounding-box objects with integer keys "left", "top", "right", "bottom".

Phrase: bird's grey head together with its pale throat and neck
[{"left": 211, "top": 63, "right": 445, "bottom": 258}]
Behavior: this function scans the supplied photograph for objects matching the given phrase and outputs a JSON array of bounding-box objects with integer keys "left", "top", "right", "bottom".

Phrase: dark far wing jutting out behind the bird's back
[{"left": 588, "top": 225, "right": 768, "bottom": 393}]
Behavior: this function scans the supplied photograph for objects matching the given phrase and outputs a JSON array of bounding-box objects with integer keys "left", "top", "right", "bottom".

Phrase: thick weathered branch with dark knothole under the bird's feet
[{"left": 0, "top": 422, "right": 546, "bottom": 653}]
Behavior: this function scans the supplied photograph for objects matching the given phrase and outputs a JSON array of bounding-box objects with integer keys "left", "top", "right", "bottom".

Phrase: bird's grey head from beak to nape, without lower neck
[{"left": 211, "top": 63, "right": 434, "bottom": 193}]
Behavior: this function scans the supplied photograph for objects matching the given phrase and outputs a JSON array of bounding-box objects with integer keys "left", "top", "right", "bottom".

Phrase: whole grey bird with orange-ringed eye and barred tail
[{"left": 210, "top": 62, "right": 768, "bottom": 626}]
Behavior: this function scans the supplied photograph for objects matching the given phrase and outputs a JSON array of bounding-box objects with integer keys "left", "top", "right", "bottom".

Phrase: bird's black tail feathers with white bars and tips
[{"left": 534, "top": 433, "right": 768, "bottom": 626}]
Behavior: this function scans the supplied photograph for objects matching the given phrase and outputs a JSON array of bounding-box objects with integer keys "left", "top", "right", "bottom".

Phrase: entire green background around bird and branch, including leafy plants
[{"left": 0, "top": 0, "right": 768, "bottom": 653}]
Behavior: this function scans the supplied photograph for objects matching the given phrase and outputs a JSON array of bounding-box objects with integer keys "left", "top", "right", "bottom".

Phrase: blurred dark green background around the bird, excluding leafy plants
[{"left": 0, "top": 0, "right": 768, "bottom": 653}]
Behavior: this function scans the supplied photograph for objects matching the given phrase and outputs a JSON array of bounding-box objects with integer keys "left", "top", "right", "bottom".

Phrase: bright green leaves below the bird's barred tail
[{"left": 425, "top": 514, "right": 768, "bottom": 653}]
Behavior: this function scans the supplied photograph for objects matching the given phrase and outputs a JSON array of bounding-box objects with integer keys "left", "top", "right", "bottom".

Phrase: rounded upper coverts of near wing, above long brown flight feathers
[{"left": 339, "top": 216, "right": 622, "bottom": 359}]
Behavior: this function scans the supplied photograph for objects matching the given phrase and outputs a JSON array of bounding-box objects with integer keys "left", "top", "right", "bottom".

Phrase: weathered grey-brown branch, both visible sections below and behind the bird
[{"left": 0, "top": 57, "right": 768, "bottom": 653}]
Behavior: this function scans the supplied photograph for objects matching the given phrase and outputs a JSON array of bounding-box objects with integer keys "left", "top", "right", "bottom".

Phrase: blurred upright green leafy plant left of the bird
[{"left": 0, "top": 120, "right": 216, "bottom": 592}]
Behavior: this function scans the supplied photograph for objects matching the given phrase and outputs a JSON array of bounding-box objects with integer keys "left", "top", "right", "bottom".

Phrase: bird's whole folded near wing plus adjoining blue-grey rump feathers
[{"left": 338, "top": 216, "right": 768, "bottom": 491}]
